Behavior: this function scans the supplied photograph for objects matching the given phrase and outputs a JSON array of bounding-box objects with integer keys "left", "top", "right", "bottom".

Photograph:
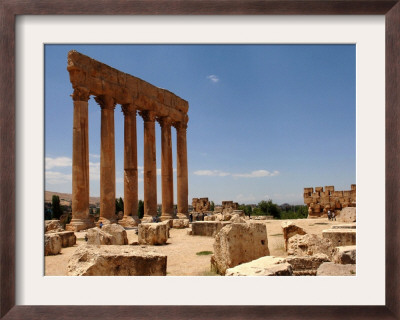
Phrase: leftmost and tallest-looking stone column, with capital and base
[{"left": 66, "top": 87, "right": 94, "bottom": 231}]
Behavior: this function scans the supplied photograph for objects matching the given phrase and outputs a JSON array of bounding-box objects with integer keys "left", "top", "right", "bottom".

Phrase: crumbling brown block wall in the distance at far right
[{"left": 304, "top": 184, "right": 356, "bottom": 218}]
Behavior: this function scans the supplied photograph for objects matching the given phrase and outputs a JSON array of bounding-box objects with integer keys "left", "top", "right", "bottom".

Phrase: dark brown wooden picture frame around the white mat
[{"left": 0, "top": 0, "right": 400, "bottom": 320}]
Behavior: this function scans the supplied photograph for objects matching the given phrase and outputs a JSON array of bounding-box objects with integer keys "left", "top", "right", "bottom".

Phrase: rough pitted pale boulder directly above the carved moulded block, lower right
[{"left": 287, "top": 234, "right": 333, "bottom": 259}]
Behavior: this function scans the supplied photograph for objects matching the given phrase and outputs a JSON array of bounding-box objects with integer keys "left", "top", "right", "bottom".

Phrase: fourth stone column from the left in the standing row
[{"left": 140, "top": 111, "right": 157, "bottom": 222}]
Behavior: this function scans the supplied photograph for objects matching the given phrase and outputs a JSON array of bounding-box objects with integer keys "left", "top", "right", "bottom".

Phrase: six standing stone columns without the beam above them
[{"left": 67, "top": 88, "right": 188, "bottom": 230}]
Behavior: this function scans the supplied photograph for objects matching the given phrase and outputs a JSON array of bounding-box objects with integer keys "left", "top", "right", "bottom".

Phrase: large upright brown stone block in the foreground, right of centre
[{"left": 211, "top": 223, "right": 269, "bottom": 274}]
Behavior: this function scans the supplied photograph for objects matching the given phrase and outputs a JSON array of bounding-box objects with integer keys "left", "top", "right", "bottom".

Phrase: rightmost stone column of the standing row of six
[{"left": 175, "top": 122, "right": 188, "bottom": 218}]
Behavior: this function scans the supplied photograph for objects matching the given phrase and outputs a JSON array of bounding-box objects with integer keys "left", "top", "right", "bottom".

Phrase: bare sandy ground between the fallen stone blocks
[{"left": 45, "top": 218, "right": 343, "bottom": 276}]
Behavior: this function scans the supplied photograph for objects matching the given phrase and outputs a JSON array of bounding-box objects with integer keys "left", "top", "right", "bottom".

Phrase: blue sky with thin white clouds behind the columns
[{"left": 45, "top": 45, "right": 356, "bottom": 204}]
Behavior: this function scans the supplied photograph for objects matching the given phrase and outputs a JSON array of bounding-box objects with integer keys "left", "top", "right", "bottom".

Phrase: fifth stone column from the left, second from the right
[{"left": 158, "top": 117, "right": 174, "bottom": 221}]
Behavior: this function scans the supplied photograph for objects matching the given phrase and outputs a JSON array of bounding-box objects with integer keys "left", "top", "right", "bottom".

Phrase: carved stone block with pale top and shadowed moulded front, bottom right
[{"left": 285, "top": 253, "right": 330, "bottom": 276}]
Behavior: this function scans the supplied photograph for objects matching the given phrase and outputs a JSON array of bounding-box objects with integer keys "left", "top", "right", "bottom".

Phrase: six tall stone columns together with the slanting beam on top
[{"left": 67, "top": 50, "right": 189, "bottom": 231}]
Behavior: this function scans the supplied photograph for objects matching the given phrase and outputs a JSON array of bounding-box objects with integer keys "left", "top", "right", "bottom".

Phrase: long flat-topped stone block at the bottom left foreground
[{"left": 67, "top": 245, "right": 167, "bottom": 276}]
